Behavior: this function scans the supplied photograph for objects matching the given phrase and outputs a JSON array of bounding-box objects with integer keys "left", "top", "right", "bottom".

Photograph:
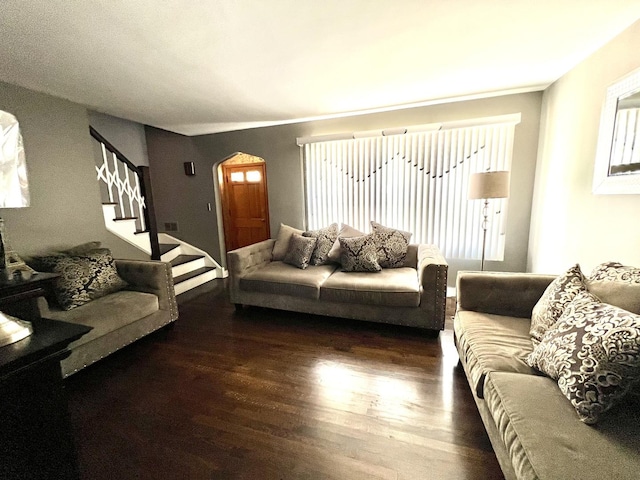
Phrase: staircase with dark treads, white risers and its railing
[{"left": 90, "top": 128, "right": 227, "bottom": 300}]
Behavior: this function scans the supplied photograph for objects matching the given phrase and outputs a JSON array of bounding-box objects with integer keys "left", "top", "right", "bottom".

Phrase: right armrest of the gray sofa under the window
[{"left": 417, "top": 244, "right": 449, "bottom": 330}]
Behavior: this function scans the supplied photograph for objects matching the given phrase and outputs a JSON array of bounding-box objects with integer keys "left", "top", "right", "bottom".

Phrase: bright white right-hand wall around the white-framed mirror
[{"left": 527, "top": 21, "right": 640, "bottom": 273}]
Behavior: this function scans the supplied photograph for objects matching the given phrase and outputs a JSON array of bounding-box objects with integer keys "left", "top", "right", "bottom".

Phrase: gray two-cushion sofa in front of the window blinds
[{"left": 227, "top": 239, "right": 448, "bottom": 331}]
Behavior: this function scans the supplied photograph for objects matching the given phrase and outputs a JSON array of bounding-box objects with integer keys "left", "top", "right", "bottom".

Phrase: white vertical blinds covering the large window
[{"left": 298, "top": 115, "right": 520, "bottom": 260}]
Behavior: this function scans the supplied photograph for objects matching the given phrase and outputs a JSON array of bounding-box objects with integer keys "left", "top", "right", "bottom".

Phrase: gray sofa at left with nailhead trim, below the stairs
[{"left": 38, "top": 260, "right": 178, "bottom": 377}]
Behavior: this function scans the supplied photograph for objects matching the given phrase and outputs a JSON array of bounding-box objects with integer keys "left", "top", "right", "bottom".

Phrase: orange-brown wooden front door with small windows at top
[{"left": 222, "top": 162, "right": 271, "bottom": 251}]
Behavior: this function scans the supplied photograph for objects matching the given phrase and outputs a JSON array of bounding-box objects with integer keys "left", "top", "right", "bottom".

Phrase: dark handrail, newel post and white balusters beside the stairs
[{"left": 89, "top": 126, "right": 160, "bottom": 260}]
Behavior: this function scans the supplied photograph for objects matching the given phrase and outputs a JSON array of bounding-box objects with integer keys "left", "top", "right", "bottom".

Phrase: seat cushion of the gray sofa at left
[{"left": 43, "top": 290, "right": 159, "bottom": 346}]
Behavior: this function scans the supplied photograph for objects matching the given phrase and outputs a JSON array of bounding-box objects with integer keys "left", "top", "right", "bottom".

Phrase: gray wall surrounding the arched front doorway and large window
[{"left": 147, "top": 92, "right": 542, "bottom": 285}]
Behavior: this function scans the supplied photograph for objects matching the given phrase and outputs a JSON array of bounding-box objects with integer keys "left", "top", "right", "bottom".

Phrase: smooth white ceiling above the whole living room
[{"left": 0, "top": 0, "right": 640, "bottom": 135}]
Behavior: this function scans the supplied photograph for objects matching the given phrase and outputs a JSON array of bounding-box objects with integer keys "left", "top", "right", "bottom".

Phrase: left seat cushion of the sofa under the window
[{"left": 240, "top": 262, "right": 336, "bottom": 299}]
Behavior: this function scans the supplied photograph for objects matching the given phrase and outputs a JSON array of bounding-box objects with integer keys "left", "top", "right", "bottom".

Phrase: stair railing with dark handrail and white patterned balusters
[{"left": 89, "top": 127, "right": 160, "bottom": 260}]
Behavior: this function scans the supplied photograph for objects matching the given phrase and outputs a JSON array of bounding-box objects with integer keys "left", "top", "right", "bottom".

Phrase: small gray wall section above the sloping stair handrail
[{"left": 88, "top": 110, "right": 149, "bottom": 166}]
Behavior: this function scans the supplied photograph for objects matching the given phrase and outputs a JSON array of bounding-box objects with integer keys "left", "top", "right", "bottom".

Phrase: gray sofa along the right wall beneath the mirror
[{"left": 454, "top": 272, "right": 640, "bottom": 480}]
